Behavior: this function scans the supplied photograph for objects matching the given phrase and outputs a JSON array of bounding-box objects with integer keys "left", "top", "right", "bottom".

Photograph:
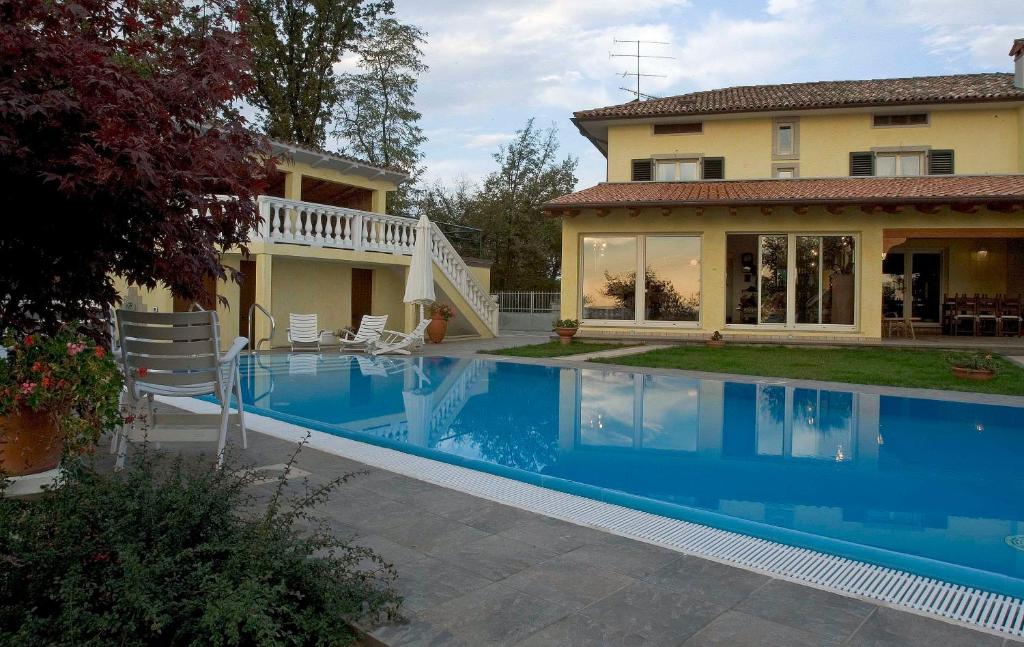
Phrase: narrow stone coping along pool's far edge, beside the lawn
[{"left": 473, "top": 353, "right": 1024, "bottom": 407}]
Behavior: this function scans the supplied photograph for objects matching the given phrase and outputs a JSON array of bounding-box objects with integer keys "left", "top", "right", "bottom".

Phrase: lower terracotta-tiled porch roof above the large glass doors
[{"left": 544, "top": 175, "right": 1024, "bottom": 211}]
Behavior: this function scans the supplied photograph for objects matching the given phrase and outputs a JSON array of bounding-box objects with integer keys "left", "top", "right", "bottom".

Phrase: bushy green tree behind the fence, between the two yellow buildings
[{"left": 466, "top": 119, "right": 578, "bottom": 290}]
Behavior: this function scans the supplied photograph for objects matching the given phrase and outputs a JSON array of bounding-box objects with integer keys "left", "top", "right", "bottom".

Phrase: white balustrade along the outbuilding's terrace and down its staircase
[{"left": 253, "top": 196, "right": 498, "bottom": 333}]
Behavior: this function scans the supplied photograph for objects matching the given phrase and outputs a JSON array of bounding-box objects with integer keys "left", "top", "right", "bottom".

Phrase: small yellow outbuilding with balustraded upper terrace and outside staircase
[{"left": 119, "top": 142, "right": 498, "bottom": 348}]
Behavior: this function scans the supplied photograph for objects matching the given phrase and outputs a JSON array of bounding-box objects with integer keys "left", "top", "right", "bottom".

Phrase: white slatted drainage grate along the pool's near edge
[{"left": 166, "top": 399, "right": 1024, "bottom": 637}]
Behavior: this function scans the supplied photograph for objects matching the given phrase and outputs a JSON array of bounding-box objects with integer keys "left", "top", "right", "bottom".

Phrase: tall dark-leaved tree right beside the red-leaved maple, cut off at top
[{"left": 243, "top": 0, "right": 393, "bottom": 146}]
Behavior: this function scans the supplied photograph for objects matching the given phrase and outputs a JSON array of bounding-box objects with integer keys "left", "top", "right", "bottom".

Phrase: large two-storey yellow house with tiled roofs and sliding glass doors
[{"left": 546, "top": 39, "right": 1024, "bottom": 339}]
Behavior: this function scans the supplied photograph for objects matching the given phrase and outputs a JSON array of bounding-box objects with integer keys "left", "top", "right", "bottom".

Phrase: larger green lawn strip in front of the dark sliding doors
[{"left": 592, "top": 346, "right": 1024, "bottom": 395}]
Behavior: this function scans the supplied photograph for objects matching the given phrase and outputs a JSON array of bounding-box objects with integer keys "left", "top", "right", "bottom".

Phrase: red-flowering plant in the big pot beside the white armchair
[{"left": 0, "top": 327, "right": 122, "bottom": 454}]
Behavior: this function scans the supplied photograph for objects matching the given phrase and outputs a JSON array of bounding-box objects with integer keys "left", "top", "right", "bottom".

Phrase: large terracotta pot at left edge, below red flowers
[{"left": 0, "top": 408, "right": 63, "bottom": 476}]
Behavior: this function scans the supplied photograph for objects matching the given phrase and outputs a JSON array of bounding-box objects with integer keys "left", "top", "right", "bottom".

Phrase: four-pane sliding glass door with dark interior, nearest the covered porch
[{"left": 726, "top": 233, "right": 857, "bottom": 330}]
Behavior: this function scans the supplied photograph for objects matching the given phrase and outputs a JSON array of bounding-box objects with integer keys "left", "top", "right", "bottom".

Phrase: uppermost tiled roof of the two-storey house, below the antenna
[{"left": 574, "top": 73, "right": 1024, "bottom": 121}]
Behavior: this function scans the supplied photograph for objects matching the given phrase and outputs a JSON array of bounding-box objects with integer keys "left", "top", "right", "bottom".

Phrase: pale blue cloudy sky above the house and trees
[{"left": 372, "top": 0, "right": 1024, "bottom": 188}]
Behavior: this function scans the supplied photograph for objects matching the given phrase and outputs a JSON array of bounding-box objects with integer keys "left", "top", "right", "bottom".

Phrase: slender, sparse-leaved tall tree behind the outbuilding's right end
[{"left": 335, "top": 17, "right": 428, "bottom": 215}]
